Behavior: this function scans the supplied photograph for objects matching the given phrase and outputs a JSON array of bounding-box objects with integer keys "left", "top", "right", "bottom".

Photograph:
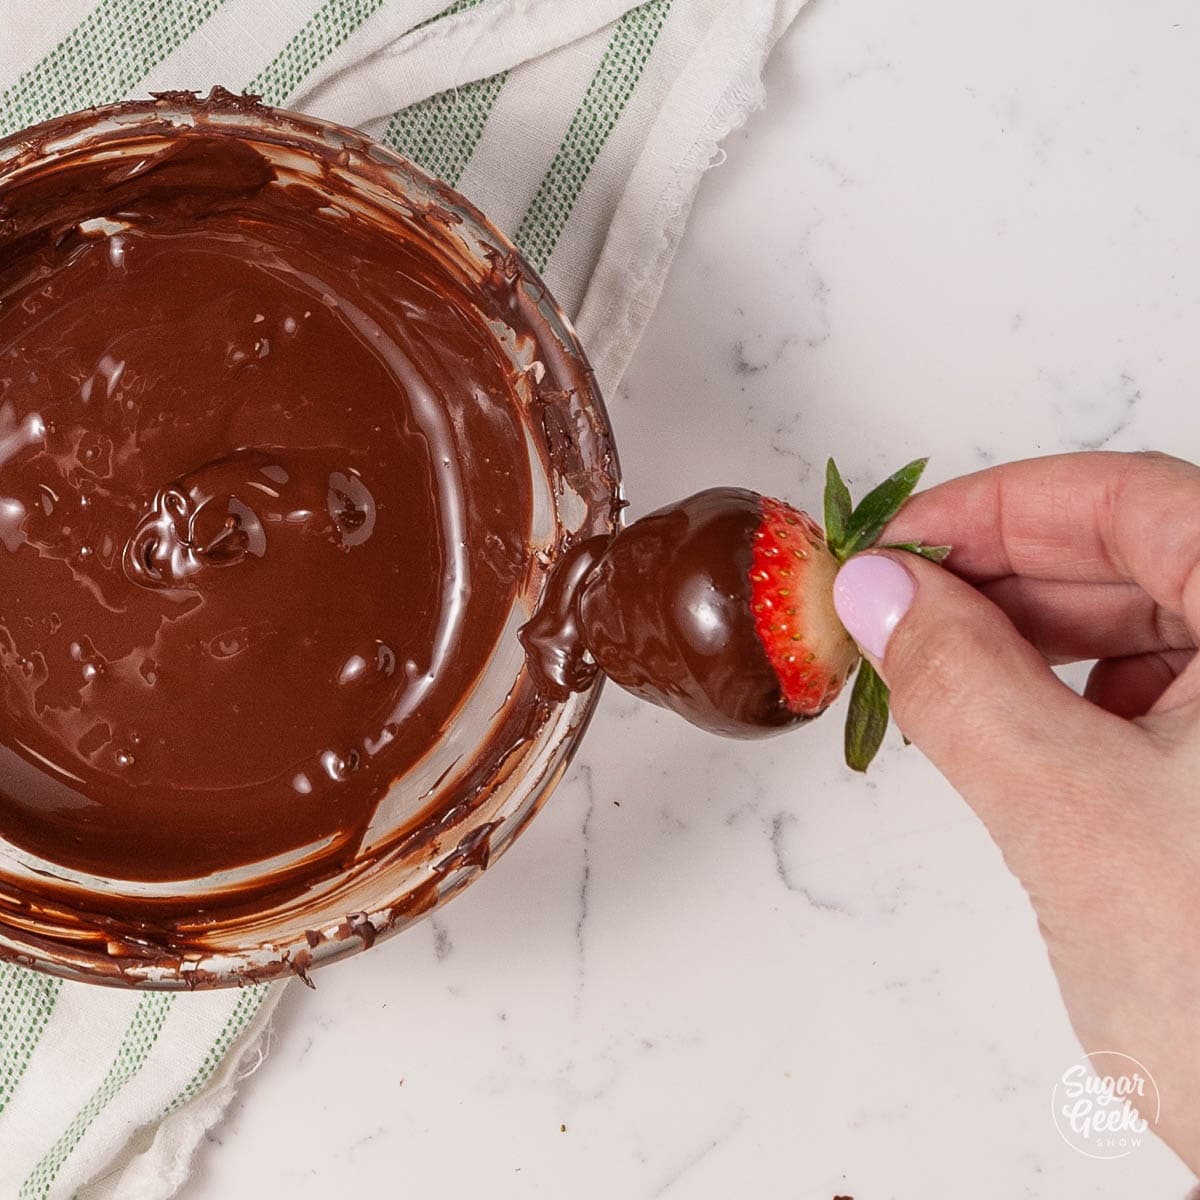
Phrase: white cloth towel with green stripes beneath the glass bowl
[{"left": 0, "top": 0, "right": 804, "bottom": 1200}]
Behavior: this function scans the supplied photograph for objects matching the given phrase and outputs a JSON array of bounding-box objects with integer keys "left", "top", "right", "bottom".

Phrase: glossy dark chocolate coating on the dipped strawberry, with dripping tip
[{"left": 522, "top": 487, "right": 804, "bottom": 737}]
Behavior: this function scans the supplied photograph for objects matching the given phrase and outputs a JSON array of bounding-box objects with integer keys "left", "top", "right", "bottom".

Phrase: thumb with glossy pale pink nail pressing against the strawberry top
[{"left": 834, "top": 551, "right": 1142, "bottom": 835}]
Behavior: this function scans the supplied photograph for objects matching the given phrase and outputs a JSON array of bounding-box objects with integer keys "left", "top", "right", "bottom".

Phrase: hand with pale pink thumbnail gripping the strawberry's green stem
[{"left": 835, "top": 454, "right": 1200, "bottom": 1172}]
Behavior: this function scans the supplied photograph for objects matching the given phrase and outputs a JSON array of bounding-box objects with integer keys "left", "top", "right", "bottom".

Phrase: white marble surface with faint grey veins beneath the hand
[{"left": 184, "top": 0, "right": 1200, "bottom": 1200}]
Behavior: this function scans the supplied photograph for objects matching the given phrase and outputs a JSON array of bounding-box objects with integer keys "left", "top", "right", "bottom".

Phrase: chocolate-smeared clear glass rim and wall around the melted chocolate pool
[{"left": 0, "top": 92, "right": 622, "bottom": 989}]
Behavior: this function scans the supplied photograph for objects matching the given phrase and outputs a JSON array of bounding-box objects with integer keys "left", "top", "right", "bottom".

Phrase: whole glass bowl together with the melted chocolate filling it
[{"left": 0, "top": 92, "right": 620, "bottom": 988}]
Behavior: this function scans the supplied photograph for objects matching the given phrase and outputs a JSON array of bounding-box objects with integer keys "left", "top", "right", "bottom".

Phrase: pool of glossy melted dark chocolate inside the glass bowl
[{"left": 0, "top": 117, "right": 532, "bottom": 883}]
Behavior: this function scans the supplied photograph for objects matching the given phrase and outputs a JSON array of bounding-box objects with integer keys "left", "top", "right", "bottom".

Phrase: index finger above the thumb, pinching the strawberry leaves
[{"left": 882, "top": 452, "right": 1200, "bottom": 632}]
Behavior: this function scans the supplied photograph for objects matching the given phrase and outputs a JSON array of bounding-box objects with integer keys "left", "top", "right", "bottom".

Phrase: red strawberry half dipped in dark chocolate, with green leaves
[{"left": 523, "top": 460, "right": 946, "bottom": 770}]
